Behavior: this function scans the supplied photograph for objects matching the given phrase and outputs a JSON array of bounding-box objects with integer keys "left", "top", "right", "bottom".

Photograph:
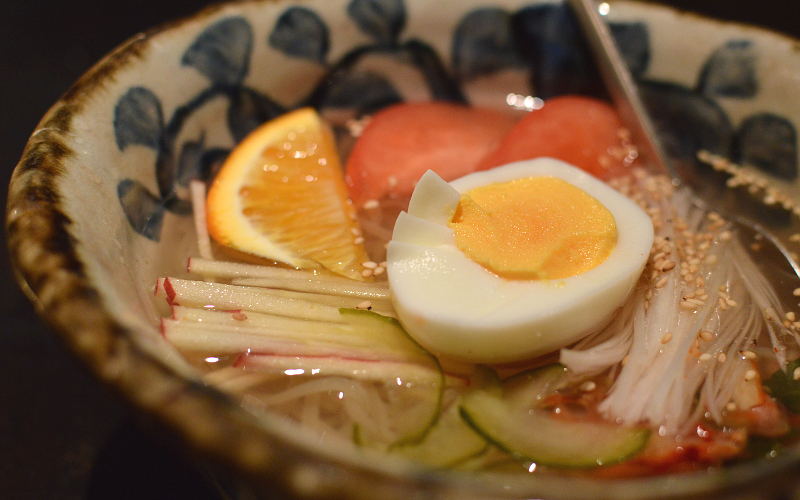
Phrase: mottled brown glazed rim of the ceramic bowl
[{"left": 6, "top": 0, "right": 798, "bottom": 498}]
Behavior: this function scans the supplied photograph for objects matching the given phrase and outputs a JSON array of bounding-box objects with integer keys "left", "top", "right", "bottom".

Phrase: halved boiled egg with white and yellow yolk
[{"left": 387, "top": 158, "right": 653, "bottom": 363}]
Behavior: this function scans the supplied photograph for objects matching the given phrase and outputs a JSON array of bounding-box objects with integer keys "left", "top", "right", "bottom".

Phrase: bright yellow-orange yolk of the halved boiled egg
[{"left": 449, "top": 177, "right": 617, "bottom": 280}]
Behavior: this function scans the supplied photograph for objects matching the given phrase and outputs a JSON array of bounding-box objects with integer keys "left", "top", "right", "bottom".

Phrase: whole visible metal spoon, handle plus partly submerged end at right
[{"left": 567, "top": 0, "right": 800, "bottom": 279}]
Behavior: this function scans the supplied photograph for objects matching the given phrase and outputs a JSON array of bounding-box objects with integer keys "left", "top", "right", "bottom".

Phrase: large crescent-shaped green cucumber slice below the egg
[{"left": 460, "top": 365, "right": 649, "bottom": 468}]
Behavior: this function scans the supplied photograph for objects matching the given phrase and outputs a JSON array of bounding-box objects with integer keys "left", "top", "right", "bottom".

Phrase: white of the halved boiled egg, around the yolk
[{"left": 387, "top": 158, "right": 653, "bottom": 363}]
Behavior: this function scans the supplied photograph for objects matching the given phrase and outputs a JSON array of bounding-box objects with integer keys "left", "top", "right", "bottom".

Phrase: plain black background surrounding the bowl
[{"left": 0, "top": 0, "right": 800, "bottom": 500}]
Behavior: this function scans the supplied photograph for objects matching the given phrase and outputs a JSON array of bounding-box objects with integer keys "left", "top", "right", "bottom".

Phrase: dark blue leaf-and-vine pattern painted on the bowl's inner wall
[{"left": 113, "top": 0, "right": 798, "bottom": 241}]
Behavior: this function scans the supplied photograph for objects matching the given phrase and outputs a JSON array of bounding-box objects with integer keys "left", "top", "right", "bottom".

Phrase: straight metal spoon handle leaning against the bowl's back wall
[{"left": 567, "top": 0, "right": 675, "bottom": 176}]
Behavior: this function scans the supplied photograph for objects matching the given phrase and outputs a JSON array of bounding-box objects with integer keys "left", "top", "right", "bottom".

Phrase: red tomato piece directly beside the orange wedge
[{"left": 345, "top": 102, "right": 517, "bottom": 207}]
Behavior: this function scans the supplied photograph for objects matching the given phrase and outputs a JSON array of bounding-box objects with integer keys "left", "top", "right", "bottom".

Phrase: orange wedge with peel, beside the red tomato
[{"left": 206, "top": 108, "right": 369, "bottom": 280}]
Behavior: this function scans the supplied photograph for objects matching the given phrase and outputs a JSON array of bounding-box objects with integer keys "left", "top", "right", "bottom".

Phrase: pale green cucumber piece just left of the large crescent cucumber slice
[{"left": 392, "top": 398, "right": 489, "bottom": 468}]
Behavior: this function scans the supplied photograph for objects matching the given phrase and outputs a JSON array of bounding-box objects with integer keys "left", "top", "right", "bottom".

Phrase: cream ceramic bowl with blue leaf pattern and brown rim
[{"left": 7, "top": 0, "right": 800, "bottom": 499}]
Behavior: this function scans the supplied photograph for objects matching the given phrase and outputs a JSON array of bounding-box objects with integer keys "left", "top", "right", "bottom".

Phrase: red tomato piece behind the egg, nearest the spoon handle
[{"left": 479, "top": 96, "right": 629, "bottom": 179}]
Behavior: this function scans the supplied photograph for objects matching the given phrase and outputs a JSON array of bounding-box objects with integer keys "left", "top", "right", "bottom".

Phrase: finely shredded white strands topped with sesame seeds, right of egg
[{"left": 561, "top": 169, "right": 796, "bottom": 434}]
